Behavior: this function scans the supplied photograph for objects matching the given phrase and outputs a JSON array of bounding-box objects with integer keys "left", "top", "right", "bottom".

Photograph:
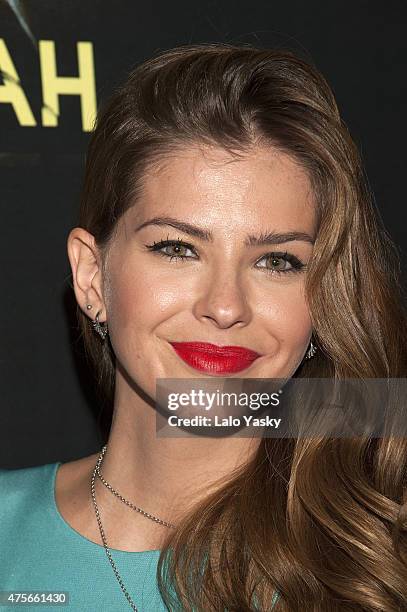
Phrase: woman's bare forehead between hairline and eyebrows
[{"left": 127, "top": 145, "right": 315, "bottom": 232}]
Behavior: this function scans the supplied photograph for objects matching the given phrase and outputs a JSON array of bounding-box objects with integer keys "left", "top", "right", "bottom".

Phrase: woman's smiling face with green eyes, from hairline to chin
[{"left": 99, "top": 147, "right": 315, "bottom": 396}]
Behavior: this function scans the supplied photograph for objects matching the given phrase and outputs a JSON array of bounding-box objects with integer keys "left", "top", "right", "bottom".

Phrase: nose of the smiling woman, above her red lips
[{"left": 194, "top": 269, "right": 252, "bottom": 329}]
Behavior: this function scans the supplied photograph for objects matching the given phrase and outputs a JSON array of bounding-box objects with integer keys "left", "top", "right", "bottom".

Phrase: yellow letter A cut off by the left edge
[{"left": 0, "top": 38, "right": 37, "bottom": 127}]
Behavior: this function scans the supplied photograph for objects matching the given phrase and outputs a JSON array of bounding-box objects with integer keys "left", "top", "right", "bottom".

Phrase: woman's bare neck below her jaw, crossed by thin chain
[{"left": 97, "top": 368, "right": 260, "bottom": 541}]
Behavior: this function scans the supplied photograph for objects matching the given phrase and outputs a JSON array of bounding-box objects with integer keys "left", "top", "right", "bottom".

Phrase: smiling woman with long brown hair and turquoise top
[{"left": 0, "top": 44, "right": 407, "bottom": 612}]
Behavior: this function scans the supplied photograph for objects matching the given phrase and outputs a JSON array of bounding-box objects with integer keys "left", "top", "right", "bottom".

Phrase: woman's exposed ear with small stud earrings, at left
[{"left": 67, "top": 227, "right": 107, "bottom": 323}]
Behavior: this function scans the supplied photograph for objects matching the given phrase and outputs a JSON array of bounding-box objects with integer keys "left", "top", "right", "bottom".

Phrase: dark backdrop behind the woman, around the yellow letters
[{"left": 0, "top": 0, "right": 407, "bottom": 468}]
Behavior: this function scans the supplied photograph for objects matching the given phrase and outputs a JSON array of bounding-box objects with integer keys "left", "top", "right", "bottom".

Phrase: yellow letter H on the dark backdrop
[{"left": 39, "top": 40, "right": 96, "bottom": 132}]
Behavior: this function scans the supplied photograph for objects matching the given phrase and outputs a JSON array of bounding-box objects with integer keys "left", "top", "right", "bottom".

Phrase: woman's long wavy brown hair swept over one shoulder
[{"left": 73, "top": 44, "right": 407, "bottom": 612}]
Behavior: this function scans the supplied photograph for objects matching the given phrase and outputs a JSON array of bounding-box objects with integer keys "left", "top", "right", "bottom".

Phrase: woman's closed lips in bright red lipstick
[{"left": 170, "top": 342, "right": 261, "bottom": 374}]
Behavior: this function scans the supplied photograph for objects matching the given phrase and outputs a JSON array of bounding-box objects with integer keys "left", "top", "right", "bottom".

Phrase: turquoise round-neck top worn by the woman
[{"left": 0, "top": 462, "right": 280, "bottom": 612}]
